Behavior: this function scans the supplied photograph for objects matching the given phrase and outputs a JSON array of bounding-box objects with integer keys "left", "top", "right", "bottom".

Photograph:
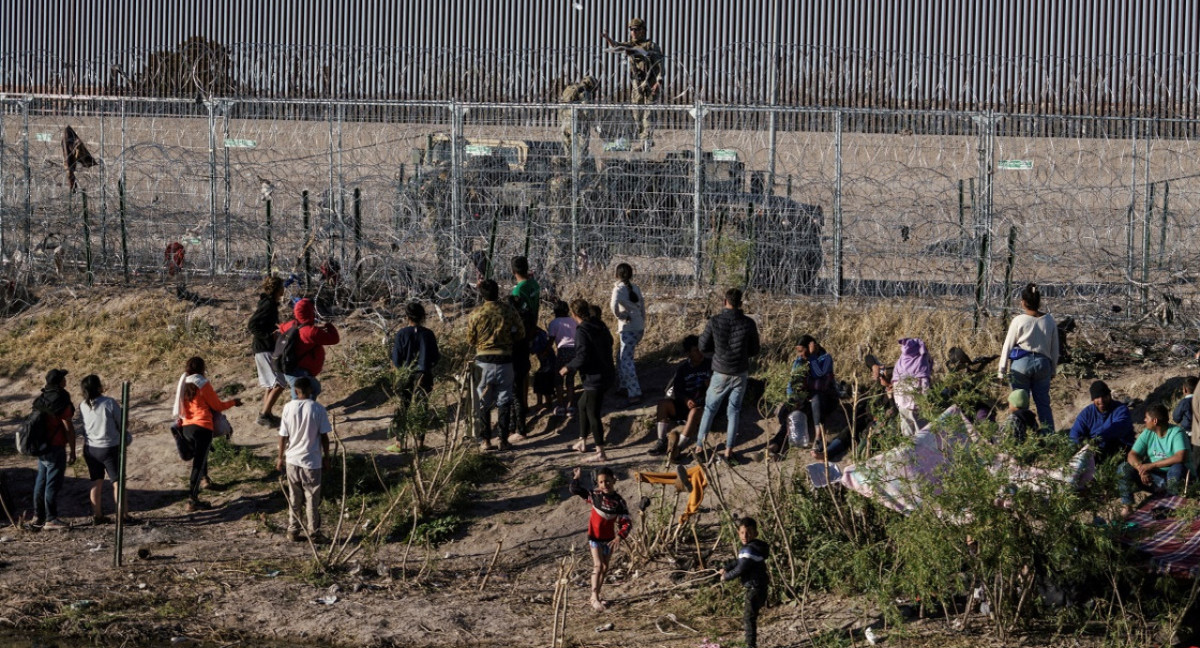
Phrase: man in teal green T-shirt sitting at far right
[{"left": 1117, "top": 404, "right": 1189, "bottom": 516}]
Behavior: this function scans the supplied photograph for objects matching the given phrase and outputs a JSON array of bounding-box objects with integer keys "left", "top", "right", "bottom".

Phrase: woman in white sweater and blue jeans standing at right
[{"left": 1000, "top": 283, "right": 1058, "bottom": 431}]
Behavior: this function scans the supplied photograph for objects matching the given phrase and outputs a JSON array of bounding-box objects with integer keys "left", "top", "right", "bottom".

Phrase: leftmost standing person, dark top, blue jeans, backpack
[{"left": 34, "top": 370, "right": 76, "bottom": 530}]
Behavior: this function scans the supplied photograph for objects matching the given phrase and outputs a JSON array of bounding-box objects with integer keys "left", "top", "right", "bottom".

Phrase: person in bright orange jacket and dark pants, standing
[{"left": 174, "top": 356, "right": 241, "bottom": 511}]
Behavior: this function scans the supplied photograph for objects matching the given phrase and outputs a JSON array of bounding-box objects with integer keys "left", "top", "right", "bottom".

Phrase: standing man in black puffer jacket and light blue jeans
[{"left": 696, "top": 288, "right": 758, "bottom": 461}]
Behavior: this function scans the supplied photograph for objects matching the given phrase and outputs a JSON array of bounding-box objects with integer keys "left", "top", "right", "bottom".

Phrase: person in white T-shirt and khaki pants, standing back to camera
[{"left": 275, "top": 377, "right": 334, "bottom": 542}]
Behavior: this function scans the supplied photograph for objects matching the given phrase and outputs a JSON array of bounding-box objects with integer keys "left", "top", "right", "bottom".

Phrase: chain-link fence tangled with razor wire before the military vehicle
[{"left": 0, "top": 97, "right": 1200, "bottom": 319}]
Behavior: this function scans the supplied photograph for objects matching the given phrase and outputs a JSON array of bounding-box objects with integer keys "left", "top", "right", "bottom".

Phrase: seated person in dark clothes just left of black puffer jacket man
[{"left": 649, "top": 335, "right": 713, "bottom": 461}]
